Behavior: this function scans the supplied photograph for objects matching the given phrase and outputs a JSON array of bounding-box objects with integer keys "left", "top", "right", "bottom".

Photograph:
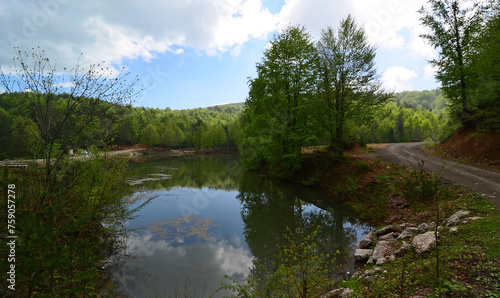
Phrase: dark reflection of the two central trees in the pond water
[{"left": 237, "top": 172, "right": 361, "bottom": 282}]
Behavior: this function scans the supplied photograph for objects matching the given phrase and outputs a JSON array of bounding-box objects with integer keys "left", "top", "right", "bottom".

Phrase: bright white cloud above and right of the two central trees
[{"left": 279, "top": 0, "right": 433, "bottom": 58}]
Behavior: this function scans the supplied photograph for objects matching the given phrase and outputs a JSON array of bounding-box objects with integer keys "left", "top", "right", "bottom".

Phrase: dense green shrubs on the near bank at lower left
[{"left": 0, "top": 158, "right": 148, "bottom": 297}]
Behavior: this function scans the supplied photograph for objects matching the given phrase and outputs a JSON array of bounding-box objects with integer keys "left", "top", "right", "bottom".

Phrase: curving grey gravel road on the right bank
[{"left": 374, "top": 142, "right": 500, "bottom": 207}]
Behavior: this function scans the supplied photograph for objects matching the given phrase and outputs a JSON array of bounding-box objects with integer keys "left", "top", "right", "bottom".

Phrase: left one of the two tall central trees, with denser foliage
[{"left": 242, "top": 26, "right": 315, "bottom": 176}]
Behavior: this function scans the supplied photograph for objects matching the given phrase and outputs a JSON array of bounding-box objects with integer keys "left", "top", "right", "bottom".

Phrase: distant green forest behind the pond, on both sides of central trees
[{"left": 0, "top": 89, "right": 458, "bottom": 159}]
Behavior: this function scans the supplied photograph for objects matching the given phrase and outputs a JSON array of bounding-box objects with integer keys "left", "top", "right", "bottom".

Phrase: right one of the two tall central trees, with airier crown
[{"left": 317, "top": 15, "right": 392, "bottom": 158}]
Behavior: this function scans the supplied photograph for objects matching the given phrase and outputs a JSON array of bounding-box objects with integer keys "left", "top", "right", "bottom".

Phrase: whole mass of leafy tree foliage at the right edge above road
[{"left": 419, "top": 0, "right": 500, "bottom": 129}]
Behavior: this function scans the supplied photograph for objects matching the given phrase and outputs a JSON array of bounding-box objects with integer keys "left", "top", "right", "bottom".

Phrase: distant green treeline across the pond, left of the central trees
[{"left": 0, "top": 93, "right": 243, "bottom": 159}]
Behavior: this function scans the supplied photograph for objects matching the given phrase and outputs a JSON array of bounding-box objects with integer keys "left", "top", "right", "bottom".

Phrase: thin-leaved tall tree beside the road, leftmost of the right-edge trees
[{"left": 419, "top": 0, "right": 484, "bottom": 123}]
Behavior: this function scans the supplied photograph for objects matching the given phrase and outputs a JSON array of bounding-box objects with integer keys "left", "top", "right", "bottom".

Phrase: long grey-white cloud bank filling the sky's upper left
[{"left": 0, "top": 0, "right": 277, "bottom": 67}]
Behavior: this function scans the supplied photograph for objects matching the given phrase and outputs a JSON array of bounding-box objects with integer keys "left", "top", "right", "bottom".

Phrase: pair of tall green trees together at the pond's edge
[{"left": 240, "top": 16, "right": 392, "bottom": 177}]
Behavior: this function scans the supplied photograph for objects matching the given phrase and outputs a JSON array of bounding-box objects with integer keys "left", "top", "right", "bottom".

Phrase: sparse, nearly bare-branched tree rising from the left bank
[{"left": 0, "top": 48, "right": 137, "bottom": 204}]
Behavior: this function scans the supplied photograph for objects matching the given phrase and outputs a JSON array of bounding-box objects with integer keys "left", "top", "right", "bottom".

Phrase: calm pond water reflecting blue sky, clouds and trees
[{"left": 113, "top": 156, "right": 370, "bottom": 297}]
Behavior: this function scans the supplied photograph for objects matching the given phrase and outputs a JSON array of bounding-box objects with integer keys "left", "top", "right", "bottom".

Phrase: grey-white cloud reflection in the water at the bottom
[{"left": 113, "top": 231, "right": 253, "bottom": 297}]
